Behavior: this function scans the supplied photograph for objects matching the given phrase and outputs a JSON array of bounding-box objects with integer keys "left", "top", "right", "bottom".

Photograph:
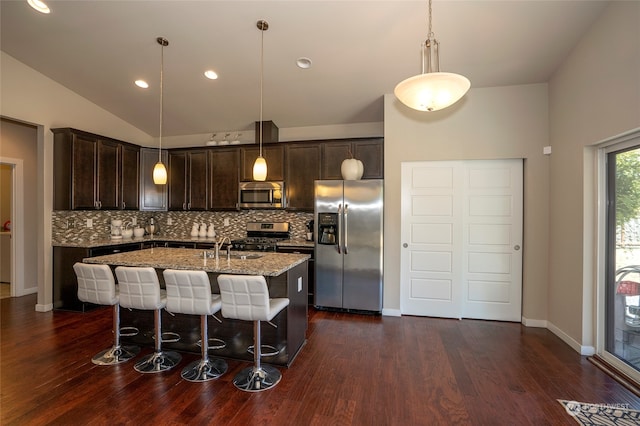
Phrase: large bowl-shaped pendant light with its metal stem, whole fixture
[{"left": 393, "top": 0, "right": 471, "bottom": 111}]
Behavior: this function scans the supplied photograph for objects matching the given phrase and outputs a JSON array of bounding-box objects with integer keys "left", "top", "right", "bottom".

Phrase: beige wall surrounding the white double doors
[{"left": 384, "top": 82, "right": 549, "bottom": 321}]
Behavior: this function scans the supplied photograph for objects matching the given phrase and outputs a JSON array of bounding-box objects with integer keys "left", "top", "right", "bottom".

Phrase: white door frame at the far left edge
[{"left": 0, "top": 157, "right": 27, "bottom": 297}]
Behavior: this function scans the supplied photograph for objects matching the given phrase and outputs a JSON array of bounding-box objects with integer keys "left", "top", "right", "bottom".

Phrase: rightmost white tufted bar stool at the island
[{"left": 218, "top": 274, "right": 289, "bottom": 392}]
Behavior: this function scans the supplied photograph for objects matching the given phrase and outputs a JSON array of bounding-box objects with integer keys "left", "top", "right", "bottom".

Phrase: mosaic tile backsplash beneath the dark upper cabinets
[{"left": 52, "top": 210, "right": 313, "bottom": 244}]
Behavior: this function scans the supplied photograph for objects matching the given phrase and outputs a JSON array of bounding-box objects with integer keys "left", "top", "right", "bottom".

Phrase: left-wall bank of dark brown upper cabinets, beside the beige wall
[{"left": 52, "top": 128, "right": 140, "bottom": 210}]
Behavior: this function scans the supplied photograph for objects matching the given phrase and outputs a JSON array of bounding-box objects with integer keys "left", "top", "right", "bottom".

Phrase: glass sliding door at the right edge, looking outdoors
[{"left": 605, "top": 139, "right": 640, "bottom": 372}]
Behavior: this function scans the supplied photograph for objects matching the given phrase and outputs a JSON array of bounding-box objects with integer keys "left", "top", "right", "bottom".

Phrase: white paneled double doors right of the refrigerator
[{"left": 400, "top": 159, "right": 523, "bottom": 322}]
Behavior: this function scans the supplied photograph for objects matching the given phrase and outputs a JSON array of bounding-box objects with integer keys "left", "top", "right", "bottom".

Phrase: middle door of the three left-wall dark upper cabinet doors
[{"left": 97, "top": 141, "right": 120, "bottom": 210}]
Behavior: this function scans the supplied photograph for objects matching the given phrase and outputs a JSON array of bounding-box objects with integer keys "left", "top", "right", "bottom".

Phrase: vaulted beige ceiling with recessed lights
[{"left": 0, "top": 0, "right": 607, "bottom": 141}]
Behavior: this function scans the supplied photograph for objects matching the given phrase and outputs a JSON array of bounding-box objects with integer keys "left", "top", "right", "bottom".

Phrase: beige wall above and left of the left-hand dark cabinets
[{"left": 0, "top": 52, "right": 151, "bottom": 310}]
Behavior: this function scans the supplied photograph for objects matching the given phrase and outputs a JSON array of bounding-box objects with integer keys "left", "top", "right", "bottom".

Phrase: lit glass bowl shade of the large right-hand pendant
[{"left": 393, "top": 72, "right": 471, "bottom": 111}]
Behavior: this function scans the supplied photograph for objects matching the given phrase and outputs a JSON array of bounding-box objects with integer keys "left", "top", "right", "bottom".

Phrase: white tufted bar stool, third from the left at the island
[{"left": 163, "top": 269, "right": 228, "bottom": 382}]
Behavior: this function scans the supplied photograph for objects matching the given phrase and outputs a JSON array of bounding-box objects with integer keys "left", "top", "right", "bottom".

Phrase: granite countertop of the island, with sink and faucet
[{"left": 83, "top": 246, "right": 310, "bottom": 277}]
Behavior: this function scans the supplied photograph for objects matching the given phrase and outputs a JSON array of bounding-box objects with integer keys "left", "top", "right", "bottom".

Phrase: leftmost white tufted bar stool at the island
[{"left": 73, "top": 262, "right": 140, "bottom": 365}]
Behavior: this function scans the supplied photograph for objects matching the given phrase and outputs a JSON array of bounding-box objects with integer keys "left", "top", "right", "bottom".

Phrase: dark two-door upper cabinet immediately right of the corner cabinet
[{"left": 167, "top": 149, "right": 209, "bottom": 210}]
